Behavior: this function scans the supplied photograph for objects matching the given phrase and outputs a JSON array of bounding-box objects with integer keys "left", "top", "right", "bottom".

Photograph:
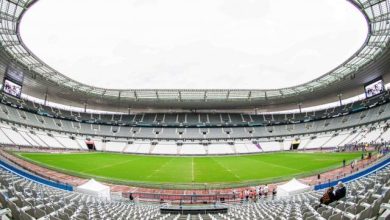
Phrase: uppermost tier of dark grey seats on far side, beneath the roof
[{"left": 0, "top": 92, "right": 389, "bottom": 129}]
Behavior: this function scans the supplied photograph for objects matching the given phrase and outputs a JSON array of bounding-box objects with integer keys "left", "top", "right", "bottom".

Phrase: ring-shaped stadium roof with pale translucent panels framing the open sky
[{"left": 0, "top": 0, "right": 390, "bottom": 109}]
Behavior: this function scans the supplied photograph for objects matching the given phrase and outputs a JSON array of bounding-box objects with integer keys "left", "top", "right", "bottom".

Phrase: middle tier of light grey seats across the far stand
[{"left": 0, "top": 97, "right": 390, "bottom": 141}]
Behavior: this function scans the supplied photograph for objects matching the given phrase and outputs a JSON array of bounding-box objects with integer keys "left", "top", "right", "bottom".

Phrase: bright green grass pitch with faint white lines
[{"left": 19, "top": 152, "right": 361, "bottom": 184}]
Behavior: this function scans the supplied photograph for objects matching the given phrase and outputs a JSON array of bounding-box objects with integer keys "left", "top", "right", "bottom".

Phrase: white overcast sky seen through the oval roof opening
[{"left": 21, "top": 0, "right": 367, "bottom": 89}]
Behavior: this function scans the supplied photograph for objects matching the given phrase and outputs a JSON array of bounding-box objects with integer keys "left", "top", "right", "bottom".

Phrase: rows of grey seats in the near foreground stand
[{"left": 0, "top": 153, "right": 390, "bottom": 220}]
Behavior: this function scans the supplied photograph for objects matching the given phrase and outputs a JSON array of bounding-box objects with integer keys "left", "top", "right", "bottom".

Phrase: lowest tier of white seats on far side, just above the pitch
[{"left": 0, "top": 105, "right": 390, "bottom": 154}]
